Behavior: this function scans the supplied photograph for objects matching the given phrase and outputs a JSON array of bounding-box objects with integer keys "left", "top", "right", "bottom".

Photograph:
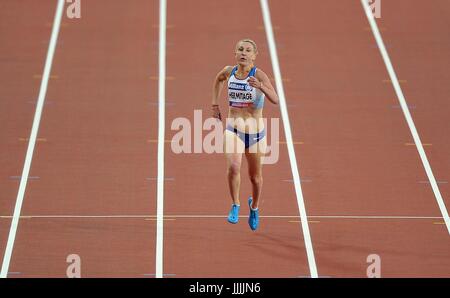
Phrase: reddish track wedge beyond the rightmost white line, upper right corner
[{"left": 379, "top": 0, "right": 450, "bottom": 217}]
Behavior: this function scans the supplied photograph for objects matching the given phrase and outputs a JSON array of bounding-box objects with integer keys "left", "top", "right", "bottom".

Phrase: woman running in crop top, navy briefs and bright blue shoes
[{"left": 212, "top": 39, "right": 279, "bottom": 231}]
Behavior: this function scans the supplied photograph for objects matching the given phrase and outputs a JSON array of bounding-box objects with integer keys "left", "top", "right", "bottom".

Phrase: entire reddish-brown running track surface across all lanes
[{"left": 0, "top": 0, "right": 450, "bottom": 277}]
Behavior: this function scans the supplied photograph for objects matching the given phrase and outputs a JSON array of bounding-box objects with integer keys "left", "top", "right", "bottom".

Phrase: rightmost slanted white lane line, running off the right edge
[{"left": 361, "top": 0, "right": 450, "bottom": 235}]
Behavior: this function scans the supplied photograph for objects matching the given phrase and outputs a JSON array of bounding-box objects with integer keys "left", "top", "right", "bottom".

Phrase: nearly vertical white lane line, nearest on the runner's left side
[{"left": 155, "top": 0, "right": 167, "bottom": 278}]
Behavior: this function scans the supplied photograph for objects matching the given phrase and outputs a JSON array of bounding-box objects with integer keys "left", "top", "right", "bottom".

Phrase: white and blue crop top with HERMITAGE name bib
[{"left": 228, "top": 66, "right": 264, "bottom": 109}]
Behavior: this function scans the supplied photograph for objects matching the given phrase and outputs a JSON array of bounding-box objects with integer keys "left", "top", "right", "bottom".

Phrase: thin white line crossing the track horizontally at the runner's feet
[{"left": 0, "top": 214, "right": 442, "bottom": 219}]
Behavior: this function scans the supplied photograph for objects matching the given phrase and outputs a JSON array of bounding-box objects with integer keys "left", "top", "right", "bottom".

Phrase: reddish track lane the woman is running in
[{"left": 164, "top": 1, "right": 309, "bottom": 277}]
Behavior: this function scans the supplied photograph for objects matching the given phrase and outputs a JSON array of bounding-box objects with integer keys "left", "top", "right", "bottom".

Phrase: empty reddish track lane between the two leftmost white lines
[{"left": 5, "top": 1, "right": 158, "bottom": 277}]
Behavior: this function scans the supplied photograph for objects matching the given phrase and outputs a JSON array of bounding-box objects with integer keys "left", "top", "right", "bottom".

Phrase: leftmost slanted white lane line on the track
[{"left": 0, "top": 0, "right": 64, "bottom": 278}]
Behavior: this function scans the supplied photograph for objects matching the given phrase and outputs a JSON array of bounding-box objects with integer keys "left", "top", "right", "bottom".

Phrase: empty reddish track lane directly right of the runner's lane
[{"left": 271, "top": 1, "right": 449, "bottom": 277}]
